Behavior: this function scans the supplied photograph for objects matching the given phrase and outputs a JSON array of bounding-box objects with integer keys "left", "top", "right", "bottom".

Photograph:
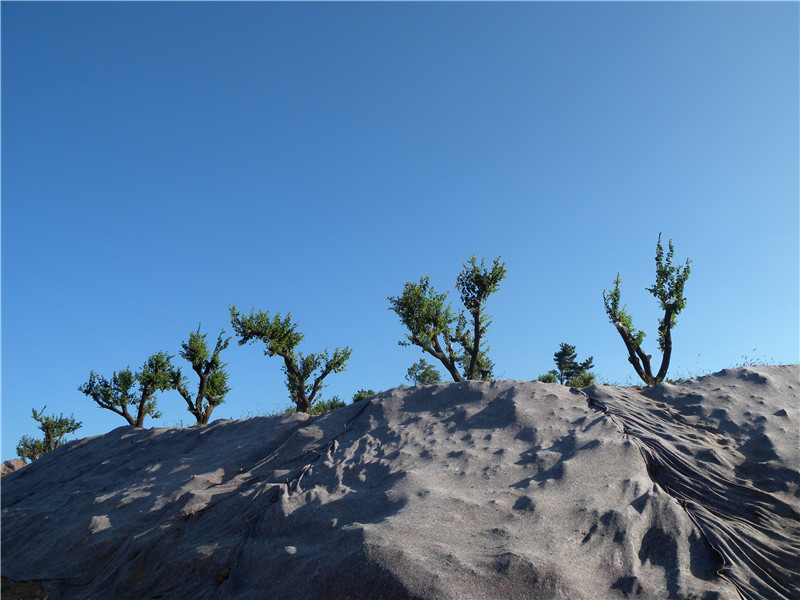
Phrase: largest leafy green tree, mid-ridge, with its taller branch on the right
[{"left": 388, "top": 254, "right": 506, "bottom": 381}]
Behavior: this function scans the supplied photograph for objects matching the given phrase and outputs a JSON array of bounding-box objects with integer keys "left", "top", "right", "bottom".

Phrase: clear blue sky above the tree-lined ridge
[{"left": 2, "top": 2, "right": 800, "bottom": 459}]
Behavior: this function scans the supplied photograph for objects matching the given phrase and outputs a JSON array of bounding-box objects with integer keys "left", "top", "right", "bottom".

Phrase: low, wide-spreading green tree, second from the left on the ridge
[{"left": 78, "top": 352, "right": 174, "bottom": 427}]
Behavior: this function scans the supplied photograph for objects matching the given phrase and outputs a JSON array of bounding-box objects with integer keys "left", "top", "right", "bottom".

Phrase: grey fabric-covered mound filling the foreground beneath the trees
[{"left": 0, "top": 365, "right": 800, "bottom": 600}]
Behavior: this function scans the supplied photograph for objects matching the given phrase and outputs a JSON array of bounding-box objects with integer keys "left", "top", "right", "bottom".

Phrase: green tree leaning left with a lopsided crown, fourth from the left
[{"left": 229, "top": 306, "right": 353, "bottom": 412}]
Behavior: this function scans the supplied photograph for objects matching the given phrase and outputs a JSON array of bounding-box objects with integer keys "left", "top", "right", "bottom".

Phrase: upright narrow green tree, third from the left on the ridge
[{"left": 172, "top": 325, "right": 231, "bottom": 426}]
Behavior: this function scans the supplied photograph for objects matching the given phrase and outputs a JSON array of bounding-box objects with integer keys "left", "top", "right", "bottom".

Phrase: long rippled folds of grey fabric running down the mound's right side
[{"left": 582, "top": 388, "right": 800, "bottom": 600}]
